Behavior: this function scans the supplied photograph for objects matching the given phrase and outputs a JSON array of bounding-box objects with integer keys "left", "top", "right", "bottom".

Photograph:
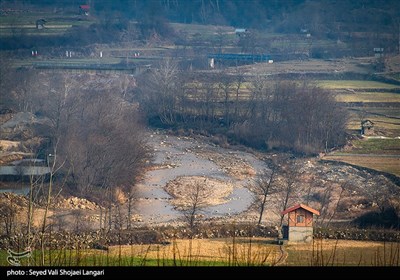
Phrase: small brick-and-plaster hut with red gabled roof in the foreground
[{"left": 281, "top": 204, "right": 319, "bottom": 242}]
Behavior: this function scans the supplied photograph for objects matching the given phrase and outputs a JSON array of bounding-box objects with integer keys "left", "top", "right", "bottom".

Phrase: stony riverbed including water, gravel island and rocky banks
[{"left": 0, "top": 130, "right": 400, "bottom": 229}]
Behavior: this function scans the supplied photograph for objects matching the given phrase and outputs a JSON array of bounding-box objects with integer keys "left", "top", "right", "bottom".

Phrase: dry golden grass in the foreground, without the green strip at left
[{"left": 76, "top": 238, "right": 400, "bottom": 266}]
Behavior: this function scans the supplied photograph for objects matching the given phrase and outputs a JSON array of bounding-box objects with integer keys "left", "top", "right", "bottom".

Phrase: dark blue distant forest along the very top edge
[{"left": 7, "top": 0, "right": 400, "bottom": 31}]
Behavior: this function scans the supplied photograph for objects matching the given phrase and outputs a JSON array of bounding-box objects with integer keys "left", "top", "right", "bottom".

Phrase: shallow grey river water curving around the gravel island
[{"left": 135, "top": 131, "right": 267, "bottom": 223}]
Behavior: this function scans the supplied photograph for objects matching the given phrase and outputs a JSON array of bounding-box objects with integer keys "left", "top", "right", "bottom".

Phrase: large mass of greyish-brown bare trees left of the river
[{"left": 1, "top": 62, "right": 150, "bottom": 200}]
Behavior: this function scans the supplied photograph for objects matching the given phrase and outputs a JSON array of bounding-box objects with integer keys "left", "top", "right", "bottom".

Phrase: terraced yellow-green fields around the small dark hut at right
[{"left": 316, "top": 80, "right": 400, "bottom": 176}]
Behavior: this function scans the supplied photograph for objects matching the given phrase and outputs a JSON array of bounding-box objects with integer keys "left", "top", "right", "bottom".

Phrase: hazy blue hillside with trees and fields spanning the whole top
[{"left": 0, "top": 0, "right": 400, "bottom": 58}]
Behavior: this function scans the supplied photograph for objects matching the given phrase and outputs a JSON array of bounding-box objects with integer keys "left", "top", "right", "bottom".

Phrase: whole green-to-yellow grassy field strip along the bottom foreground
[{"left": 0, "top": 238, "right": 400, "bottom": 266}]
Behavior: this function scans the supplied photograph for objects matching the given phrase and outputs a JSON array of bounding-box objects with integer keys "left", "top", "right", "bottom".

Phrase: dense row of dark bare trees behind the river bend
[{"left": 137, "top": 60, "right": 347, "bottom": 154}]
